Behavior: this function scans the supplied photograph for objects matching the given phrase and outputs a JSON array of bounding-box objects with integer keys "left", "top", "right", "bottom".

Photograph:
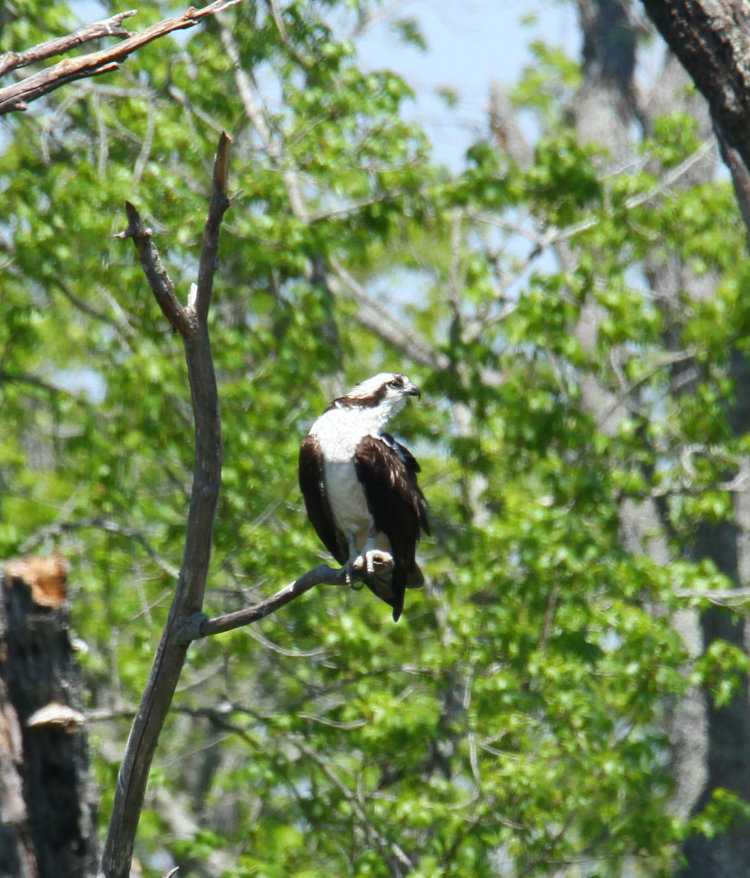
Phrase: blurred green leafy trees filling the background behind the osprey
[{"left": 0, "top": 0, "right": 750, "bottom": 878}]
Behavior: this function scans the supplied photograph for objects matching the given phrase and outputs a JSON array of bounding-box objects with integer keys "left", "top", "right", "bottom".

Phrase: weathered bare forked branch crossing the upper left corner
[{"left": 0, "top": 0, "right": 242, "bottom": 115}]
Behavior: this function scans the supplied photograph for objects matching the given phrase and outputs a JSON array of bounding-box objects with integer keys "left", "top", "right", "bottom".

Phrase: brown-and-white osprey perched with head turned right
[{"left": 299, "top": 372, "right": 430, "bottom": 621}]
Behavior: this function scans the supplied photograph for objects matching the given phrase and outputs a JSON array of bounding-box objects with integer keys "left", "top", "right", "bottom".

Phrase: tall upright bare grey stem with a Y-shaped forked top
[{"left": 101, "top": 132, "right": 231, "bottom": 878}]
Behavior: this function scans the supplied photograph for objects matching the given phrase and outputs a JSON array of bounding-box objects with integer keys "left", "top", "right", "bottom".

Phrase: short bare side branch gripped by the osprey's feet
[{"left": 175, "top": 552, "right": 393, "bottom": 644}]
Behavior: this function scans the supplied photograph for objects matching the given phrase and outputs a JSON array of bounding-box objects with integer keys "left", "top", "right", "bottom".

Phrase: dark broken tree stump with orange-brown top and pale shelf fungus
[{"left": 0, "top": 556, "right": 98, "bottom": 878}]
